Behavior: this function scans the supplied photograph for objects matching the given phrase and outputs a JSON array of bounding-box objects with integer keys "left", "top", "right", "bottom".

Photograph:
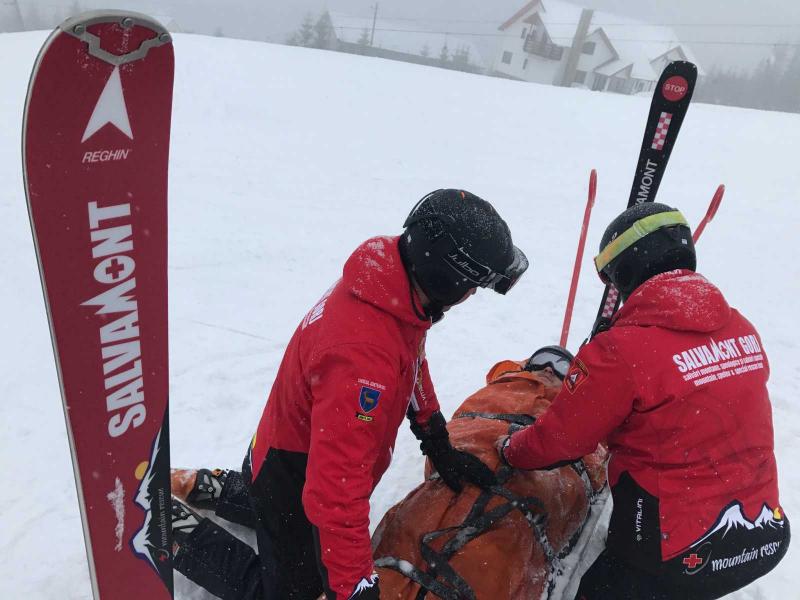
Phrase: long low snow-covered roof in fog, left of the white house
[{"left": 328, "top": 11, "right": 484, "bottom": 66}]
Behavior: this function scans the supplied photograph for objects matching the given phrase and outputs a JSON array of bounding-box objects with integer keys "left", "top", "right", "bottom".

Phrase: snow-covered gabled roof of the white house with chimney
[{"left": 500, "top": 0, "right": 697, "bottom": 80}]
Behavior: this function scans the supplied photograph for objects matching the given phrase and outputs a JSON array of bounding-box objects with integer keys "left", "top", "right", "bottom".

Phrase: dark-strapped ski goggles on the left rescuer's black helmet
[{"left": 403, "top": 211, "right": 529, "bottom": 295}]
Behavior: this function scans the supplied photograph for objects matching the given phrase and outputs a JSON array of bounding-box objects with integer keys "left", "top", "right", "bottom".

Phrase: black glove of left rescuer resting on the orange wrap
[{"left": 411, "top": 410, "right": 497, "bottom": 492}]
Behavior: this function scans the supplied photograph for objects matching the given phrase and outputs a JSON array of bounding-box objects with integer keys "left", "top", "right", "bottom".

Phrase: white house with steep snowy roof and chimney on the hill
[{"left": 491, "top": 0, "right": 697, "bottom": 94}]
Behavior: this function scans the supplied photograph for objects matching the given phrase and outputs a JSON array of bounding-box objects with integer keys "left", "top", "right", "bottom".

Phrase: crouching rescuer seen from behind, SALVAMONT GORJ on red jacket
[{"left": 499, "top": 204, "right": 790, "bottom": 600}]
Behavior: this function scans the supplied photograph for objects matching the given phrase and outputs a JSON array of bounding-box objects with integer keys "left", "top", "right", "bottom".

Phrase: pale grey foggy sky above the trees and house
[{"left": 7, "top": 0, "right": 800, "bottom": 70}]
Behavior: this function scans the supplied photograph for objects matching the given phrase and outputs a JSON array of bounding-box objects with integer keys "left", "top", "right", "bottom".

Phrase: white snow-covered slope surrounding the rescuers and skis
[{"left": 0, "top": 33, "right": 800, "bottom": 600}]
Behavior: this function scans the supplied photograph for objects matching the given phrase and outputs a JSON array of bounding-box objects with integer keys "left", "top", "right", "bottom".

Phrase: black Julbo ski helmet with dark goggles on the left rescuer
[{"left": 400, "top": 189, "right": 528, "bottom": 315}]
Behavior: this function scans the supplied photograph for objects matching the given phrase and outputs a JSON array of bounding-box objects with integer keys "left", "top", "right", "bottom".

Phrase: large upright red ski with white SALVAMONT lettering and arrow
[{"left": 23, "top": 11, "right": 173, "bottom": 600}]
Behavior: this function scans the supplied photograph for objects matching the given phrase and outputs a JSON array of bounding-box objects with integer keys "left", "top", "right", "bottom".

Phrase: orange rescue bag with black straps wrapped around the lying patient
[{"left": 372, "top": 361, "right": 607, "bottom": 600}]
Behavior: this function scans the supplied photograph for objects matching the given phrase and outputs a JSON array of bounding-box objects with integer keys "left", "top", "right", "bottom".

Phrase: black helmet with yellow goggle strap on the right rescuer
[{"left": 594, "top": 202, "right": 697, "bottom": 299}]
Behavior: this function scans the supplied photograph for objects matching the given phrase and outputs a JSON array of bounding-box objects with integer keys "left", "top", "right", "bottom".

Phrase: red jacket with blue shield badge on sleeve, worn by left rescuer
[{"left": 250, "top": 237, "right": 439, "bottom": 598}]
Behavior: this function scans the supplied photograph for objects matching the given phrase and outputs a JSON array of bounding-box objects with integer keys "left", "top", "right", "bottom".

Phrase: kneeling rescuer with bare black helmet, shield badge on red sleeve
[{"left": 173, "top": 189, "right": 528, "bottom": 600}]
